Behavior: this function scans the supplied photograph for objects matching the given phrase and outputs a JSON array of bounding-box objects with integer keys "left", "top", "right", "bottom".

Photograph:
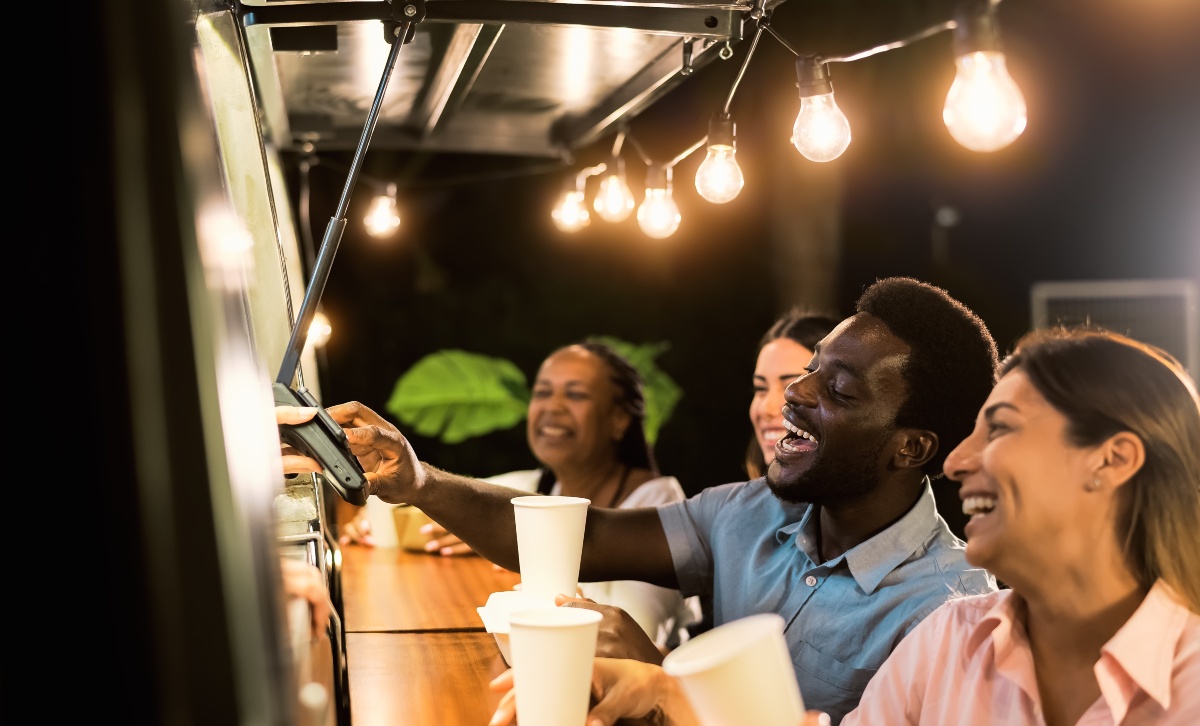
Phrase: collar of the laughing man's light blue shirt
[{"left": 775, "top": 476, "right": 937, "bottom": 594}]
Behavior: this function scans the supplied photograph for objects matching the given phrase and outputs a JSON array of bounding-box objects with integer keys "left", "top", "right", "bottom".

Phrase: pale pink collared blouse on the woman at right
[{"left": 841, "top": 581, "right": 1200, "bottom": 726}]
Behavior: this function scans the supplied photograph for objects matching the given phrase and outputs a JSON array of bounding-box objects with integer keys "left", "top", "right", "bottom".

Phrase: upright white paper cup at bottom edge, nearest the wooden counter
[{"left": 509, "top": 607, "right": 601, "bottom": 726}]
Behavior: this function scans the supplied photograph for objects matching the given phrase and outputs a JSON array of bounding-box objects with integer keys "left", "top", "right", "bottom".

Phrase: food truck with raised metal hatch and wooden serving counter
[{"left": 87, "top": 0, "right": 758, "bottom": 726}]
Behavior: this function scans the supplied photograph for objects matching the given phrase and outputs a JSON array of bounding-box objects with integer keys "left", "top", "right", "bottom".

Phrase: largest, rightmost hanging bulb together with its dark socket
[{"left": 942, "top": 1, "right": 1027, "bottom": 151}]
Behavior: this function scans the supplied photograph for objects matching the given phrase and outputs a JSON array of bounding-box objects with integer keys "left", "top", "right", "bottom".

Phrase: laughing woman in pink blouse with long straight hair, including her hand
[{"left": 493, "top": 329, "right": 1200, "bottom": 726}]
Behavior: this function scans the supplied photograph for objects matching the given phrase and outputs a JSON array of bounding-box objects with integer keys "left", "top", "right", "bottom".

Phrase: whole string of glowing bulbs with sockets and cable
[{"left": 307, "top": 0, "right": 1027, "bottom": 239}]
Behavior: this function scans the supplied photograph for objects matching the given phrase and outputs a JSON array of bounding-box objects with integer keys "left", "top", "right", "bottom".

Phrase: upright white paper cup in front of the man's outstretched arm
[{"left": 512, "top": 494, "right": 592, "bottom": 606}]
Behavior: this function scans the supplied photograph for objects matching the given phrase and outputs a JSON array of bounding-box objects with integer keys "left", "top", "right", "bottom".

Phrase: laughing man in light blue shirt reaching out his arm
[{"left": 319, "top": 277, "right": 997, "bottom": 722}]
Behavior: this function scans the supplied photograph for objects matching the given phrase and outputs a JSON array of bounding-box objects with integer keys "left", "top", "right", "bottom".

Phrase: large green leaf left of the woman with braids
[{"left": 386, "top": 349, "right": 529, "bottom": 444}]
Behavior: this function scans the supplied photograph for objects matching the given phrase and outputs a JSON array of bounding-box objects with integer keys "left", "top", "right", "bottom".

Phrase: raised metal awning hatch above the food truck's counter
[{"left": 238, "top": 0, "right": 782, "bottom": 157}]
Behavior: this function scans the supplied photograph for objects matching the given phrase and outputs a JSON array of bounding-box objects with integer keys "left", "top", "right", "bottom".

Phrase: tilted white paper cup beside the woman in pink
[{"left": 662, "top": 613, "right": 804, "bottom": 726}]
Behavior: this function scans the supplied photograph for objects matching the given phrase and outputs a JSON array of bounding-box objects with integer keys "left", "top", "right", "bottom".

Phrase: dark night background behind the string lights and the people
[{"left": 284, "top": 0, "right": 1200, "bottom": 532}]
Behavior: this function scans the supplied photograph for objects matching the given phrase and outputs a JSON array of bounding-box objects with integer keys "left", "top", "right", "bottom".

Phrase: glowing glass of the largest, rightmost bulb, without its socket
[{"left": 942, "top": 50, "right": 1027, "bottom": 151}]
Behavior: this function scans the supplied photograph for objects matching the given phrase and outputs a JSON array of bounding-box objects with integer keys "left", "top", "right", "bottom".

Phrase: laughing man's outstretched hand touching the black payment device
[{"left": 326, "top": 401, "right": 425, "bottom": 504}]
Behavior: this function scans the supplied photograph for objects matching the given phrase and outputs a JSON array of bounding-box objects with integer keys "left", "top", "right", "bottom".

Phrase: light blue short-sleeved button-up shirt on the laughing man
[{"left": 659, "top": 479, "right": 996, "bottom": 724}]
